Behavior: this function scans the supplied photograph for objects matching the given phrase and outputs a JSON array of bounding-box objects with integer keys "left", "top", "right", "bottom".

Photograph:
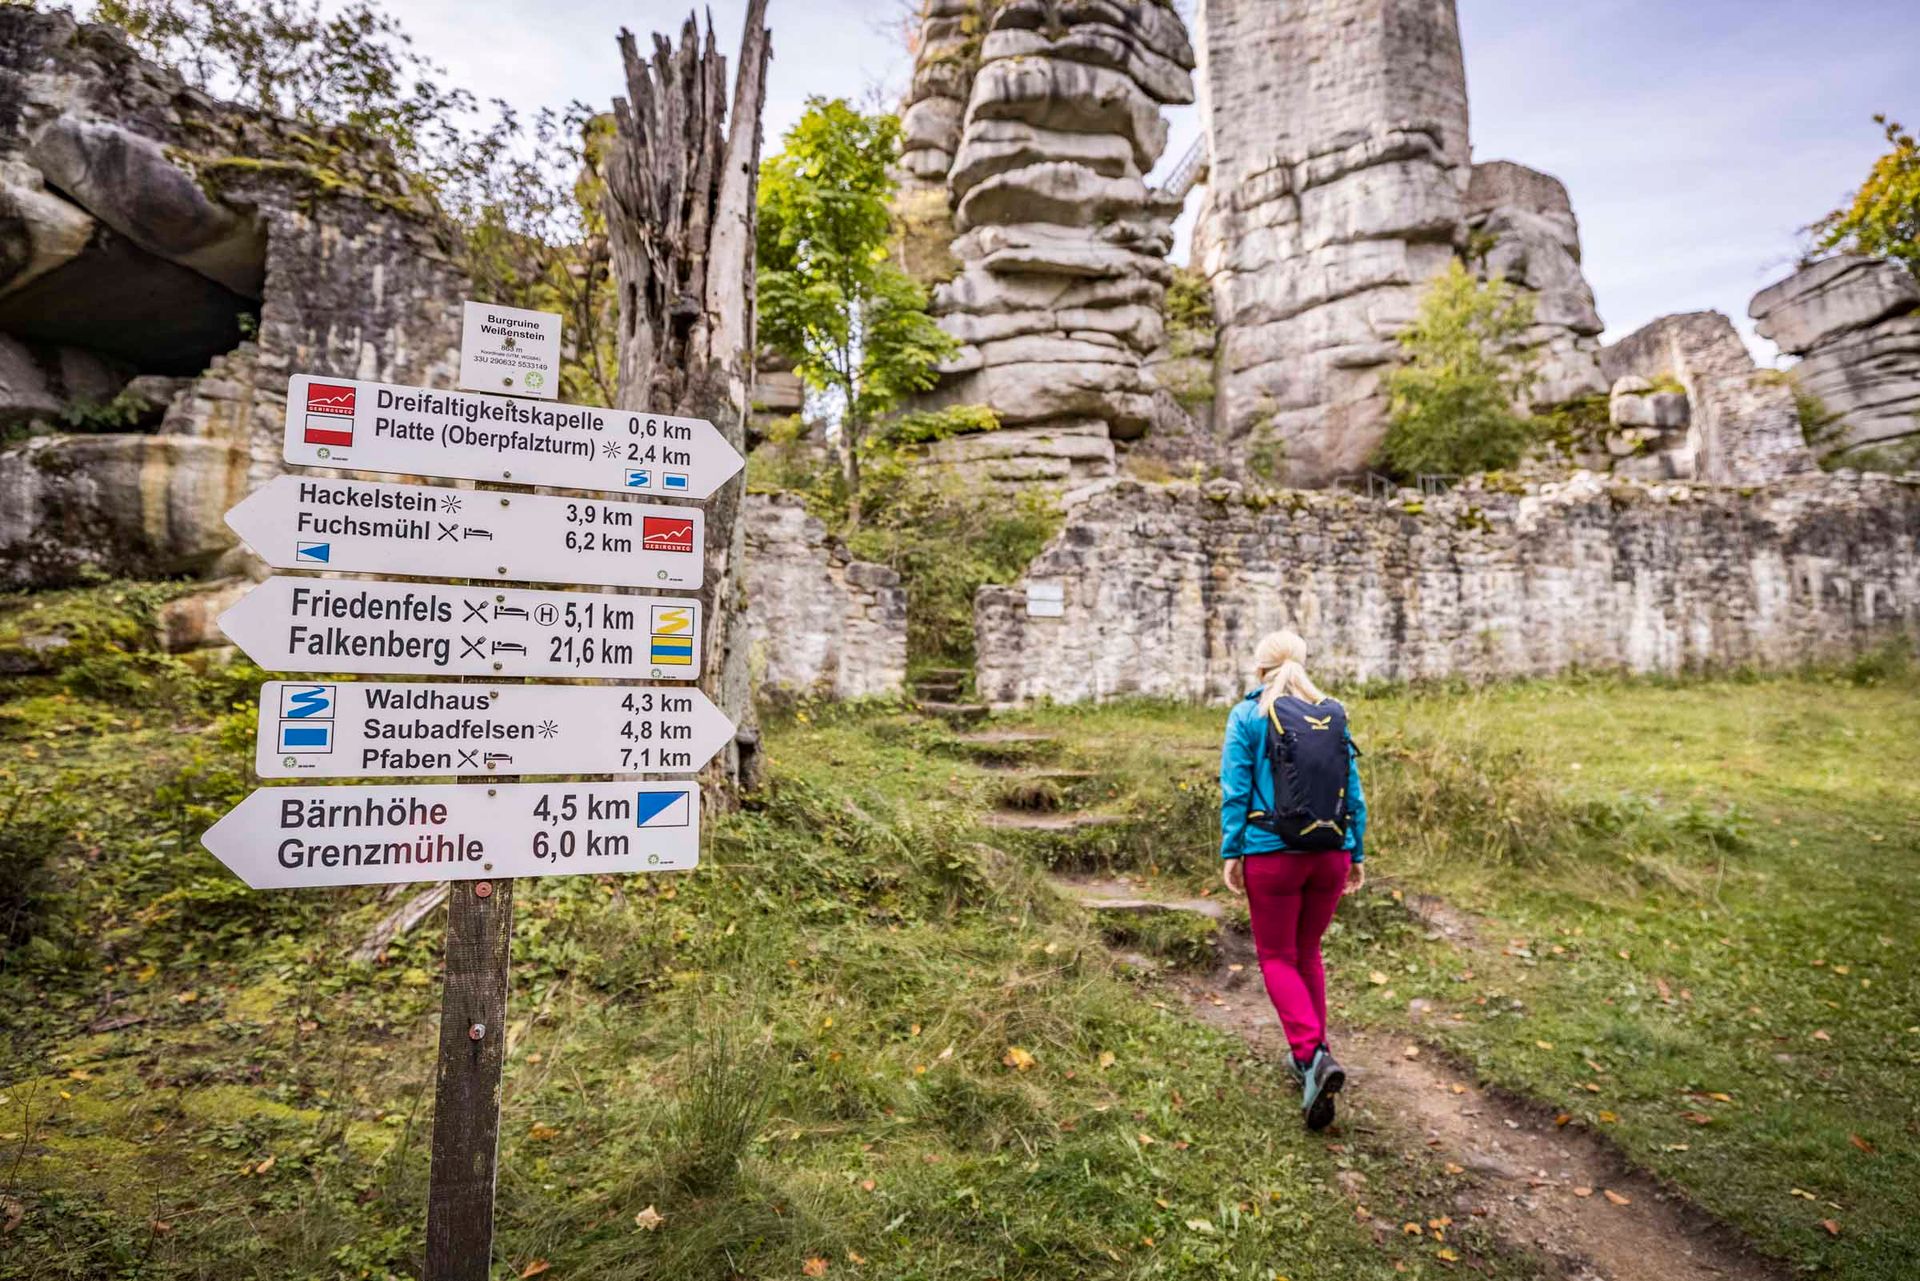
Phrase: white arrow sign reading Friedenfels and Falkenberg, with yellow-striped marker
[{"left": 221, "top": 578, "right": 701, "bottom": 680}]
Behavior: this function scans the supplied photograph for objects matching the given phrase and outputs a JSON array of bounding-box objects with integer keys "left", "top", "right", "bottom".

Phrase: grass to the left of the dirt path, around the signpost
[{"left": 0, "top": 590, "right": 1526, "bottom": 1281}]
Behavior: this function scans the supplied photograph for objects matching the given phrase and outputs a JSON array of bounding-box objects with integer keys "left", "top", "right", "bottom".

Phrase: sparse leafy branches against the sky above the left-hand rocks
[{"left": 94, "top": 0, "right": 616, "bottom": 405}]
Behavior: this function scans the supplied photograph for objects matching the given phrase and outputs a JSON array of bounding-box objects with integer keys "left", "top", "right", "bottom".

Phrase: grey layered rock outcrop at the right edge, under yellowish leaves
[{"left": 1747, "top": 254, "right": 1920, "bottom": 459}]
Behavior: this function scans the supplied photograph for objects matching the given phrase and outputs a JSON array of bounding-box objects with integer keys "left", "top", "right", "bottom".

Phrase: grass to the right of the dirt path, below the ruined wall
[{"left": 990, "top": 663, "right": 1920, "bottom": 1281}]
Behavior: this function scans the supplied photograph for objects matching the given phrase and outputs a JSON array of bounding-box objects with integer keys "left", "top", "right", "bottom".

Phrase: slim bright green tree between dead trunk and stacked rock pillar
[{"left": 758, "top": 98, "right": 956, "bottom": 524}]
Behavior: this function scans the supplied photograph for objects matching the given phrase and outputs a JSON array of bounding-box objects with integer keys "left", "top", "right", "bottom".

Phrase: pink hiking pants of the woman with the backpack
[{"left": 1240, "top": 849, "right": 1350, "bottom": 1060}]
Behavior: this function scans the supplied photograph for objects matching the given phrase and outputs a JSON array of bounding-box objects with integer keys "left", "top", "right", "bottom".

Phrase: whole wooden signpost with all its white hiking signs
[{"left": 202, "top": 309, "right": 745, "bottom": 1281}]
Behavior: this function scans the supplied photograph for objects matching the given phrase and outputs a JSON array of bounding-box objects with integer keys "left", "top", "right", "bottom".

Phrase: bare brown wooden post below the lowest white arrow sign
[{"left": 426, "top": 880, "right": 513, "bottom": 1281}]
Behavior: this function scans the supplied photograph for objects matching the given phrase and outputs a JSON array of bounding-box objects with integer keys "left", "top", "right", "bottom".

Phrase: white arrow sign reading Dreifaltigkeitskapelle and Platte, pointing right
[{"left": 284, "top": 375, "right": 747, "bottom": 499}]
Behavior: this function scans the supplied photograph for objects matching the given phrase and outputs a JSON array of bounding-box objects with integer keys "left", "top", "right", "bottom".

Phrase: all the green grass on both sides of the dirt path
[{"left": 0, "top": 586, "right": 1920, "bottom": 1281}]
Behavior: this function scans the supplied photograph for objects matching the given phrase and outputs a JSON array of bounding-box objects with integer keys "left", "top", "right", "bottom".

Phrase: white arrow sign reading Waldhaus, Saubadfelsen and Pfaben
[{"left": 253, "top": 680, "right": 733, "bottom": 778}]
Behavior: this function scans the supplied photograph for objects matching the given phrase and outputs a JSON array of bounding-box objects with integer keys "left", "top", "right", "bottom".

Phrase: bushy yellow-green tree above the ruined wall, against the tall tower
[{"left": 1380, "top": 261, "right": 1534, "bottom": 476}]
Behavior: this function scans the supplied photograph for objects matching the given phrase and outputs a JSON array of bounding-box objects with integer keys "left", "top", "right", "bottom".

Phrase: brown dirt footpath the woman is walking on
[{"left": 1056, "top": 880, "right": 1786, "bottom": 1281}]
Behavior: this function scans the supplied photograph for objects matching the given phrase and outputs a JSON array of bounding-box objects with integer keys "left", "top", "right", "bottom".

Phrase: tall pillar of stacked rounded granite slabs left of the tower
[{"left": 916, "top": 0, "right": 1194, "bottom": 460}]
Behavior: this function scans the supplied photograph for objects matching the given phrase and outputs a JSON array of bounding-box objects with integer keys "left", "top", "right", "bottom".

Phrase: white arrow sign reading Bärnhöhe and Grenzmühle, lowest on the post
[{"left": 200, "top": 782, "right": 701, "bottom": 889}]
